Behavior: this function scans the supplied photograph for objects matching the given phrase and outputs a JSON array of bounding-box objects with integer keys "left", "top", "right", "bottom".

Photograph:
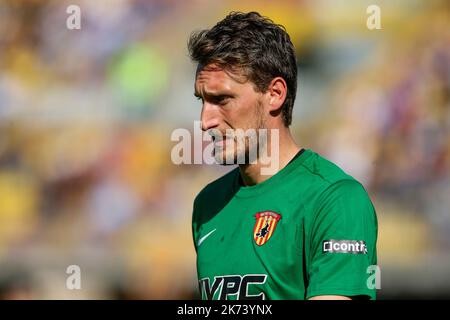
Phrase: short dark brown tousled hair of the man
[{"left": 188, "top": 12, "right": 297, "bottom": 126}]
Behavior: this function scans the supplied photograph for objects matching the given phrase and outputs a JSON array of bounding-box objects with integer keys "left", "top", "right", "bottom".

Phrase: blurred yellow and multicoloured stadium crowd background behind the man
[{"left": 0, "top": 0, "right": 450, "bottom": 299}]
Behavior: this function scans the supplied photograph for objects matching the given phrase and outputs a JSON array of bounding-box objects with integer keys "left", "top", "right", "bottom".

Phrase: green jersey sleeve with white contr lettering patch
[{"left": 306, "top": 180, "right": 378, "bottom": 299}]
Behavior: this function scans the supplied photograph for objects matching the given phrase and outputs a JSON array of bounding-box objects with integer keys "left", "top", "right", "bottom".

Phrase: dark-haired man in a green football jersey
[{"left": 188, "top": 12, "right": 377, "bottom": 299}]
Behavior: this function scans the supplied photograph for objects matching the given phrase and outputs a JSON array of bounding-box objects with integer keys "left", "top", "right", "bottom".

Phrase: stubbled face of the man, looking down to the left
[{"left": 195, "top": 65, "right": 266, "bottom": 164}]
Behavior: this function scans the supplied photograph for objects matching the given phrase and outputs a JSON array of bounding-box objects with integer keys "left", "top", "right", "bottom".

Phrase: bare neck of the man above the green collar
[{"left": 239, "top": 128, "right": 301, "bottom": 186}]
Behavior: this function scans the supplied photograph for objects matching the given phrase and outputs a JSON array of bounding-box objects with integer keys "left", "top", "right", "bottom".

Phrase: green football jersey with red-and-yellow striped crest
[{"left": 192, "top": 150, "right": 377, "bottom": 300}]
